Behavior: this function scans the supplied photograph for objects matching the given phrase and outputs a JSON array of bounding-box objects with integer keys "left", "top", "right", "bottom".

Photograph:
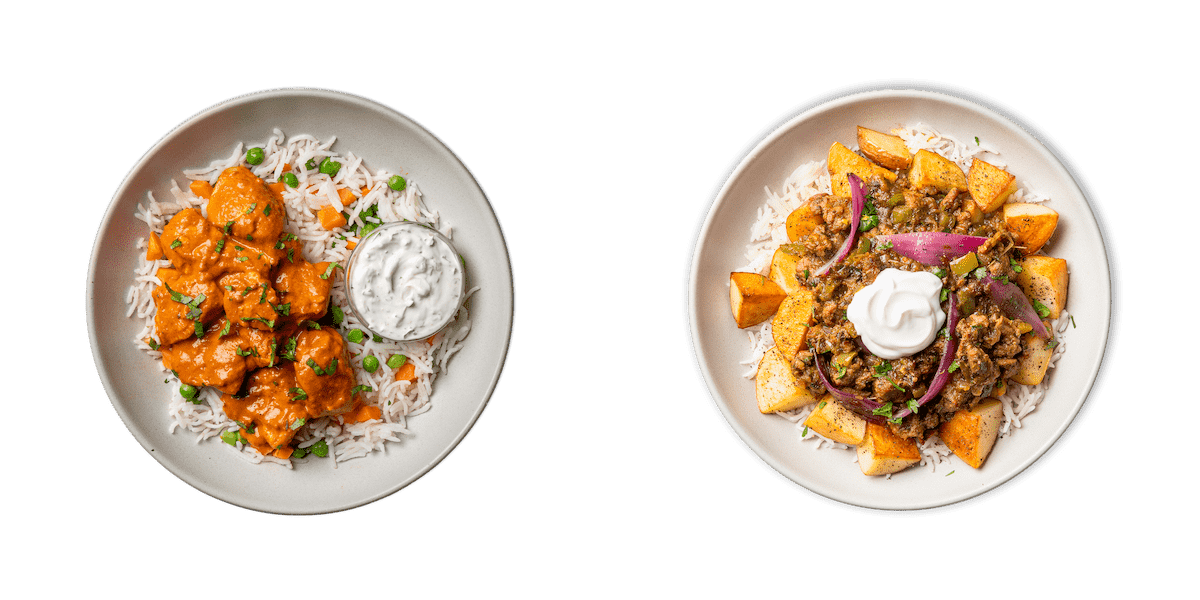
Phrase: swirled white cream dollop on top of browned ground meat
[{"left": 846, "top": 269, "right": 946, "bottom": 360}]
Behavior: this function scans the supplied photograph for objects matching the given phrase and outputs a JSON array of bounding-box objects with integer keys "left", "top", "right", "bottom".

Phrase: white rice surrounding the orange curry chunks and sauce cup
[{"left": 126, "top": 128, "right": 479, "bottom": 468}]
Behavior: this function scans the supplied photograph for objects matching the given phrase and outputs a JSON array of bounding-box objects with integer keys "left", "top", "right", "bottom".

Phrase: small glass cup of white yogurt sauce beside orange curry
[{"left": 346, "top": 222, "right": 463, "bottom": 341}]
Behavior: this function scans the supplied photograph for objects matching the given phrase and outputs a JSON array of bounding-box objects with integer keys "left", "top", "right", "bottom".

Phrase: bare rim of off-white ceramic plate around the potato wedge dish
[{"left": 688, "top": 90, "right": 1112, "bottom": 510}]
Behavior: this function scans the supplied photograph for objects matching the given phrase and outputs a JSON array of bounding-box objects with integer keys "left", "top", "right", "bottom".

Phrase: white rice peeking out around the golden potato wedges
[{"left": 736, "top": 124, "right": 1072, "bottom": 472}]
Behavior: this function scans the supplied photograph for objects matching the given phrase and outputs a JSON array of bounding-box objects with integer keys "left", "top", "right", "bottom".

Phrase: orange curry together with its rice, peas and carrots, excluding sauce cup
[{"left": 128, "top": 130, "right": 474, "bottom": 467}]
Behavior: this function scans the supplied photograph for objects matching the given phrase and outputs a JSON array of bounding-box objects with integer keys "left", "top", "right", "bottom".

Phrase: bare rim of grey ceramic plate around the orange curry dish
[{"left": 86, "top": 89, "right": 514, "bottom": 514}]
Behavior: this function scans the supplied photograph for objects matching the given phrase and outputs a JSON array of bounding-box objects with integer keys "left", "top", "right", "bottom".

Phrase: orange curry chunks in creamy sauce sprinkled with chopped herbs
[{"left": 146, "top": 167, "right": 379, "bottom": 458}]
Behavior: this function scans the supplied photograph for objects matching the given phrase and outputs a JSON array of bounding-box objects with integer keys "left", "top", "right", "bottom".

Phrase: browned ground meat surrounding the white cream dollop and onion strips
[{"left": 793, "top": 173, "right": 1021, "bottom": 439}]
